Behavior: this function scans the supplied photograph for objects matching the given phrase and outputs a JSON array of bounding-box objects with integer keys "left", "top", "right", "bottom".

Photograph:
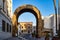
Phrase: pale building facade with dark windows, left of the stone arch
[{"left": 0, "top": 0, "right": 12, "bottom": 32}]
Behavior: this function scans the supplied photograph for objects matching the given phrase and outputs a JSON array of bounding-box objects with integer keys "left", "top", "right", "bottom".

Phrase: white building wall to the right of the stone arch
[{"left": 44, "top": 14, "right": 58, "bottom": 36}]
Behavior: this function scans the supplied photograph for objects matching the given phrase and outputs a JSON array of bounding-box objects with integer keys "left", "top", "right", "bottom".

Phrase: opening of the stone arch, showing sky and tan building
[{"left": 18, "top": 12, "right": 37, "bottom": 36}]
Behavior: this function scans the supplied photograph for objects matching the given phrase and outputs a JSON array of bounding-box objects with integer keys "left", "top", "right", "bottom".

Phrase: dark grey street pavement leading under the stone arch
[{"left": 4, "top": 34, "right": 44, "bottom": 40}]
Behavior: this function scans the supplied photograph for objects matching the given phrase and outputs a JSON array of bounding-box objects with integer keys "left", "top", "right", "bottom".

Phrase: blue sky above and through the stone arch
[{"left": 13, "top": 0, "right": 58, "bottom": 24}]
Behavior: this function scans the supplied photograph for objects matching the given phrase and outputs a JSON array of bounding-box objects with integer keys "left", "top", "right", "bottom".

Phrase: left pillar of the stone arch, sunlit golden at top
[{"left": 12, "top": 14, "right": 18, "bottom": 37}]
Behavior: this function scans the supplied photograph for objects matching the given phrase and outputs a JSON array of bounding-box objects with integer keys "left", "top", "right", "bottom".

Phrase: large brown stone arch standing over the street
[{"left": 12, "top": 5, "right": 43, "bottom": 37}]
